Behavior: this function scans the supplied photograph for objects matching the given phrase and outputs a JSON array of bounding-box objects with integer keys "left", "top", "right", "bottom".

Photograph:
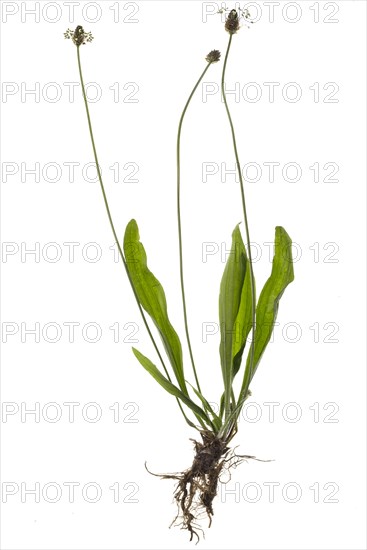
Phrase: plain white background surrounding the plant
[{"left": 1, "top": 1, "right": 366, "bottom": 550}]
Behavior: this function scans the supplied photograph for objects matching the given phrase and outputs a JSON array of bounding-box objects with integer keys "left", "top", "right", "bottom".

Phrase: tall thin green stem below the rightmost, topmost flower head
[{"left": 221, "top": 33, "right": 256, "bottom": 431}]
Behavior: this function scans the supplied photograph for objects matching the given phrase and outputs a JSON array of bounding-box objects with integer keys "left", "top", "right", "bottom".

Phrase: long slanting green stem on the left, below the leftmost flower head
[{"left": 76, "top": 46, "right": 197, "bottom": 432}]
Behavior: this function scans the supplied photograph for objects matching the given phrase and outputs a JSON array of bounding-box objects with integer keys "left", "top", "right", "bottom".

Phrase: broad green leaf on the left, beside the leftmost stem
[{"left": 124, "top": 220, "right": 188, "bottom": 395}]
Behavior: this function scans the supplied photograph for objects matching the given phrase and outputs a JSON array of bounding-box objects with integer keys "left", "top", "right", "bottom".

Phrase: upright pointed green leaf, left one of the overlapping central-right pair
[{"left": 219, "top": 225, "right": 247, "bottom": 414}]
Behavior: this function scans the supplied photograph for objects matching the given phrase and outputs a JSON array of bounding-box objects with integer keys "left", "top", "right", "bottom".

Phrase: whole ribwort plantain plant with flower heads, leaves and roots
[{"left": 65, "top": 10, "right": 294, "bottom": 540}]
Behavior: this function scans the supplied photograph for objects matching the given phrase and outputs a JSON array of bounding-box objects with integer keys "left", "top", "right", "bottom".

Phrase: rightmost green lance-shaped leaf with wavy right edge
[{"left": 239, "top": 226, "right": 294, "bottom": 401}]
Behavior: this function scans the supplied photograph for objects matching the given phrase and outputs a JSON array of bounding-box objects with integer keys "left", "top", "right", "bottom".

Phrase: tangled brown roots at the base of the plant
[{"left": 145, "top": 431, "right": 264, "bottom": 542}]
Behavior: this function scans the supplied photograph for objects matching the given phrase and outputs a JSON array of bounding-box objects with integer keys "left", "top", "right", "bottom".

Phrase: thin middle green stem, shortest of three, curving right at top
[{"left": 176, "top": 61, "right": 212, "bottom": 393}]
